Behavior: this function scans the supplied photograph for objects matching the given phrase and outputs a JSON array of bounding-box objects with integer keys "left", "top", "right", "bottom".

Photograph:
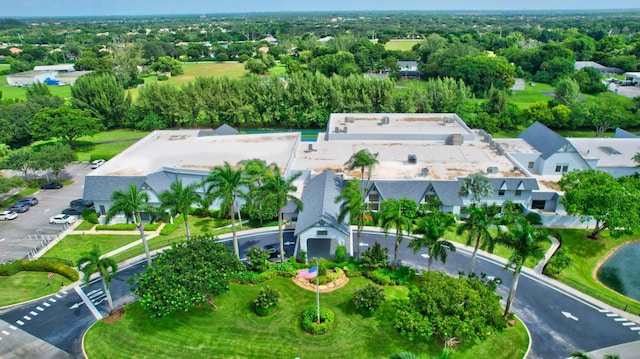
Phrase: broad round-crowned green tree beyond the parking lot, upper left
[{"left": 31, "top": 105, "right": 102, "bottom": 149}]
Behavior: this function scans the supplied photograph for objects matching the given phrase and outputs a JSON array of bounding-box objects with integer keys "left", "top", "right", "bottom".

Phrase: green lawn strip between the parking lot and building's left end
[{"left": 43, "top": 234, "right": 140, "bottom": 263}]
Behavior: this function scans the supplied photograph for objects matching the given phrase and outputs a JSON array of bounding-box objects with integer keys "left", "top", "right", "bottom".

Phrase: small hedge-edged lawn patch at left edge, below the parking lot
[{"left": 0, "top": 272, "right": 70, "bottom": 307}]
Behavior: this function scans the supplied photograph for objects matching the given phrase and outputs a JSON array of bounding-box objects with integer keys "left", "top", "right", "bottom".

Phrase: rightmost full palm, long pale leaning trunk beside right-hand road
[{"left": 498, "top": 216, "right": 547, "bottom": 317}]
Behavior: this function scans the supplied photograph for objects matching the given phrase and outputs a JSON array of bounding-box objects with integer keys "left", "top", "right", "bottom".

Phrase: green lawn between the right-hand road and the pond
[{"left": 551, "top": 229, "right": 640, "bottom": 314}]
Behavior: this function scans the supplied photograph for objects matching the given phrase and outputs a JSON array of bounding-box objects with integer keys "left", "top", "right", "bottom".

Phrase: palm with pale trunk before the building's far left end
[{"left": 105, "top": 183, "right": 157, "bottom": 266}]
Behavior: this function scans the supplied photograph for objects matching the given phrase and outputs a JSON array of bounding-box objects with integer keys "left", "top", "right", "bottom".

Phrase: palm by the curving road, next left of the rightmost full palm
[{"left": 456, "top": 203, "right": 498, "bottom": 274}]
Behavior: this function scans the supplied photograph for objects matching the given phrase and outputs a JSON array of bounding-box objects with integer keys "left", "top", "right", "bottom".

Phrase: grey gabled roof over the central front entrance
[{"left": 294, "top": 171, "right": 350, "bottom": 236}]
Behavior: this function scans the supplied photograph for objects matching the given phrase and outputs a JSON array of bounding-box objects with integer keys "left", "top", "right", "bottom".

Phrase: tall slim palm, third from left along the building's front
[{"left": 204, "top": 161, "right": 249, "bottom": 258}]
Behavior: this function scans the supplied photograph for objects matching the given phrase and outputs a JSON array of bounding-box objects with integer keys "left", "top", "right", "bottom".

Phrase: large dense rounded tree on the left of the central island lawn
[{"left": 129, "top": 237, "right": 243, "bottom": 317}]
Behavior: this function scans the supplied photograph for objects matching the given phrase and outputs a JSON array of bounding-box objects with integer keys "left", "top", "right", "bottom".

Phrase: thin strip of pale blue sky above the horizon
[{"left": 0, "top": 0, "right": 640, "bottom": 18}]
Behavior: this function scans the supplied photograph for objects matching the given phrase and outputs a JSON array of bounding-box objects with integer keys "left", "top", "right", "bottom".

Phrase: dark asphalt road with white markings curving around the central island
[{"left": 0, "top": 231, "right": 640, "bottom": 359}]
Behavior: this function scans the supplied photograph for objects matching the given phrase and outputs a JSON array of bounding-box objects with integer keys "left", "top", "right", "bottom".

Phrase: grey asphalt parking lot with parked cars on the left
[{"left": 0, "top": 163, "right": 91, "bottom": 263}]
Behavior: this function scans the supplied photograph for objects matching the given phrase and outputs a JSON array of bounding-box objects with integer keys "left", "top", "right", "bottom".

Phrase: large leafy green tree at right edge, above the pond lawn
[{"left": 558, "top": 169, "right": 640, "bottom": 239}]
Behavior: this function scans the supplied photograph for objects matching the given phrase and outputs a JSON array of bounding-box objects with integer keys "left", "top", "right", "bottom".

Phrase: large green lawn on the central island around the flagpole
[{"left": 85, "top": 277, "right": 526, "bottom": 358}]
